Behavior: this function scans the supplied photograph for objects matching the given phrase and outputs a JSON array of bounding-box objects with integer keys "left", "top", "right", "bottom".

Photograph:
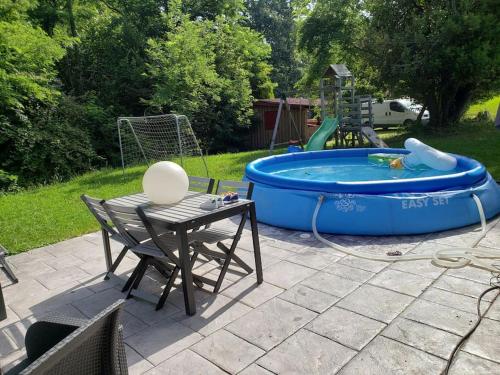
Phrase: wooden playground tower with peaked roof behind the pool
[{"left": 320, "top": 64, "right": 387, "bottom": 147}]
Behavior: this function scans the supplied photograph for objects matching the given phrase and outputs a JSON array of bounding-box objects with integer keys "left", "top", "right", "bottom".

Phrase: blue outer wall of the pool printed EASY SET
[{"left": 246, "top": 149, "right": 500, "bottom": 235}]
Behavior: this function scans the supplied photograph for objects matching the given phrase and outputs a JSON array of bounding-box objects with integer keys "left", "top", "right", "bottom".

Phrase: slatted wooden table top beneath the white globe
[{"left": 109, "top": 191, "right": 252, "bottom": 224}]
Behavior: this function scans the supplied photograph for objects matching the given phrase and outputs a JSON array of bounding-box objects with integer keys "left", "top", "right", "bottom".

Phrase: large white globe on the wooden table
[{"left": 142, "top": 161, "right": 189, "bottom": 204}]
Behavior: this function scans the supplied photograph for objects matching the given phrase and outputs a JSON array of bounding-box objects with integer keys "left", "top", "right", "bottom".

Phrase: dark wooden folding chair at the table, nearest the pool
[{"left": 188, "top": 180, "right": 253, "bottom": 293}]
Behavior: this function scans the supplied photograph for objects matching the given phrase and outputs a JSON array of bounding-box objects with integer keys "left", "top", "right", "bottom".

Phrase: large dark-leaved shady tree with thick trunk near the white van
[{"left": 365, "top": 0, "right": 500, "bottom": 127}]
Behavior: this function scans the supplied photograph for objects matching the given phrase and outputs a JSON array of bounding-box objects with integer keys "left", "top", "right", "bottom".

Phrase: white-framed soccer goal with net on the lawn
[{"left": 117, "top": 114, "right": 208, "bottom": 176}]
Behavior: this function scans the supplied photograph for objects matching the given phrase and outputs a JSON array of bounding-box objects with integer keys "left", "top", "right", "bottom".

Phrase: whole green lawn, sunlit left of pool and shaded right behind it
[{"left": 0, "top": 122, "right": 500, "bottom": 253}]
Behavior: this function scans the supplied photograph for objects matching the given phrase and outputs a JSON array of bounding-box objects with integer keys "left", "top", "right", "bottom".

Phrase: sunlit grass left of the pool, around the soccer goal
[{"left": 0, "top": 151, "right": 278, "bottom": 253}]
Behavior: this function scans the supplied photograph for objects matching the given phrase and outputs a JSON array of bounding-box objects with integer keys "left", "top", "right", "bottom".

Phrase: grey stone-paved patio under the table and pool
[{"left": 0, "top": 219, "right": 500, "bottom": 375}]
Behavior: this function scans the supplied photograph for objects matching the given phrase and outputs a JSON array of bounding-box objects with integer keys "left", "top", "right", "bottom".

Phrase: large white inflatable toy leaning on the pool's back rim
[{"left": 391, "top": 138, "right": 457, "bottom": 171}]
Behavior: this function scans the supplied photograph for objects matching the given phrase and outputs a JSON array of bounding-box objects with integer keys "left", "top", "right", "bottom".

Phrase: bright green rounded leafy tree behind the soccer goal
[{"left": 148, "top": 12, "right": 273, "bottom": 151}]
